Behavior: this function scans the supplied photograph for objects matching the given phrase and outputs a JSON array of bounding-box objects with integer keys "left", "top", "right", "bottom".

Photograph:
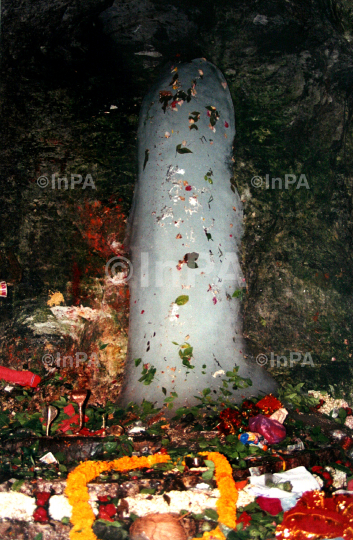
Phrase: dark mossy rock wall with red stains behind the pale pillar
[{"left": 0, "top": 0, "right": 353, "bottom": 404}]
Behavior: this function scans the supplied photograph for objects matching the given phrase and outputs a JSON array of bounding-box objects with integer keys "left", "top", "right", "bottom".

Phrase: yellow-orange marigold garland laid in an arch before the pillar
[{"left": 65, "top": 452, "right": 238, "bottom": 540}]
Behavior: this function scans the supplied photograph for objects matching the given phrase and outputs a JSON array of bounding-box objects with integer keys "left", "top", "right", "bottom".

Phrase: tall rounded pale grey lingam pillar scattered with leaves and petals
[{"left": 121, "top": 59, "right": 276, "bottom": 410}]
